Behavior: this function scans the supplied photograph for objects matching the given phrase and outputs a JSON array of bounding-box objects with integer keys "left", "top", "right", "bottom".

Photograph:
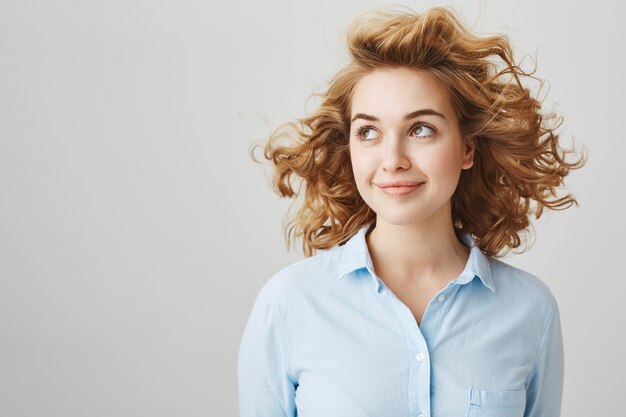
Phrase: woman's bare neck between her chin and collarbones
[{"left": 366, "top": 200, "right": 469, "bottom": 285}]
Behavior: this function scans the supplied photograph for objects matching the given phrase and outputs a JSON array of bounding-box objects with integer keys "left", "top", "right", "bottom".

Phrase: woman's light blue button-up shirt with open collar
[{"left": 238, "top": 226, "right": 564, "bottom": 417}]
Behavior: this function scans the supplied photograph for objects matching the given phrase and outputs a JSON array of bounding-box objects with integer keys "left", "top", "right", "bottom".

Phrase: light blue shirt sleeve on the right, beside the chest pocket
[{"left": 524, "top": 299, "right": 564, "bottom": 417}]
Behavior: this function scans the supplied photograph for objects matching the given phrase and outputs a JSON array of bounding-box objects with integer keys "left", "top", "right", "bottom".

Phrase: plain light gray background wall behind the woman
[{"left": 0, "top": 0, "right": 626, "bottom": 417}]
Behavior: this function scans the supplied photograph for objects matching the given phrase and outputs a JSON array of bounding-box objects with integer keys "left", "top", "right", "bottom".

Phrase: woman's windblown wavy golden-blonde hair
[{"left": 251, "top": 7, "right": 586, "bottom": 257}]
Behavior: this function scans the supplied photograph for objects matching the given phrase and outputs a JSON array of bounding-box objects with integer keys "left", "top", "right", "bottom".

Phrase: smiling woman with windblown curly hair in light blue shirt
[{"left": 238, "top": 8, "right": 584, "bottom": 417}]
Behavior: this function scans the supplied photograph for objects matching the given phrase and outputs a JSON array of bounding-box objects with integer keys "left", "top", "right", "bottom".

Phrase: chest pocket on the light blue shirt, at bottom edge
[{"left": 467, "top": 389, "right": 526, "bottom": 417}]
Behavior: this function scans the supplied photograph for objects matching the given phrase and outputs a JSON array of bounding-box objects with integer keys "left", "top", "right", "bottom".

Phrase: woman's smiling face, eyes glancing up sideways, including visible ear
[{"left": 350, "top": 68, "right": 474, "bottom": 225}]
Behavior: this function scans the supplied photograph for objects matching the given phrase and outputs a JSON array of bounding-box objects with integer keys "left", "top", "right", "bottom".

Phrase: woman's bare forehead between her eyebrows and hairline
[{"left": 350, "top": 68, "right": 453, "bottom": 120}]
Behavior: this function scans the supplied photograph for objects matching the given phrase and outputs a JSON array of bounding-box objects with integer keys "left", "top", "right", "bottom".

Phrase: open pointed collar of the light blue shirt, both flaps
[{"left": 337, "top": 224, "right": 496, "bottom": 292}]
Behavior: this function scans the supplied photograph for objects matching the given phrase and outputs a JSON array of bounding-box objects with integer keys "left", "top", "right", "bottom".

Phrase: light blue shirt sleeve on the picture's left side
[{"left": 237, "top": 281, "right": 297, "bottom": 417}]
